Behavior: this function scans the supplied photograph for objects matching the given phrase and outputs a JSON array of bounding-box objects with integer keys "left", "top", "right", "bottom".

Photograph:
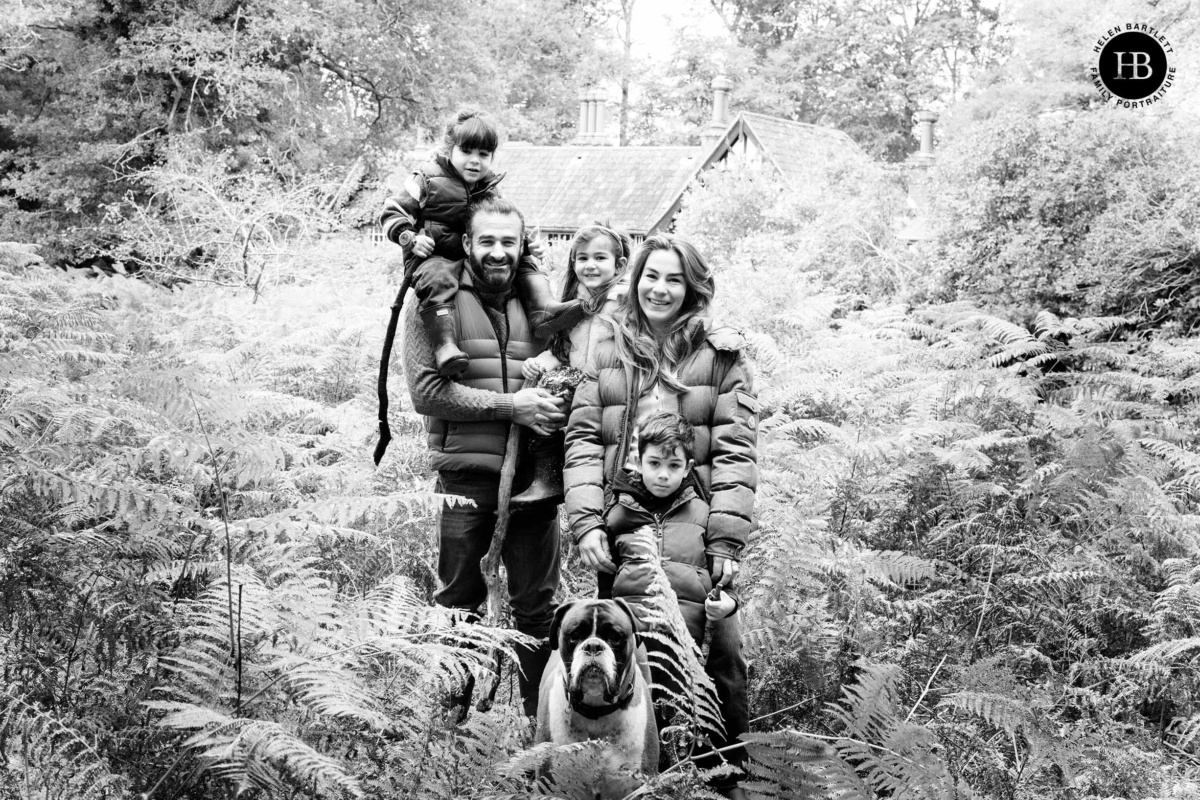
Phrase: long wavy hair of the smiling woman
[{"left": 613, "top": 234, "right": 716, "bottom": 392}]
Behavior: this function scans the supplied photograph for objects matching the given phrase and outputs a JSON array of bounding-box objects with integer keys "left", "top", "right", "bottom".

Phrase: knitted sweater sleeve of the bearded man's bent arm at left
[{"left": 401, "top": 302, "right": 512, "bottom": 422}]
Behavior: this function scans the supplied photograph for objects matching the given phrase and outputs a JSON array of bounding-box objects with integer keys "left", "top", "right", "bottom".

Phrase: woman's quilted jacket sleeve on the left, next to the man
[{"left": 563, "top": 369, "right": 604, "bottom": 545}]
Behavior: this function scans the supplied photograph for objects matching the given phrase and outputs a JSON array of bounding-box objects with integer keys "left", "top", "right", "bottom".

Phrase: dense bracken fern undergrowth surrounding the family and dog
[{"left": 0, "top": 226, "right": 1200, "bottom": 799}]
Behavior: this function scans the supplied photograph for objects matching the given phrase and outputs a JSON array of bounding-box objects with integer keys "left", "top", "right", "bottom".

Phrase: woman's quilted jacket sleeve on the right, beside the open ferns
[{"left": 704, "top": 353, "right": 758, "bottom": 559}]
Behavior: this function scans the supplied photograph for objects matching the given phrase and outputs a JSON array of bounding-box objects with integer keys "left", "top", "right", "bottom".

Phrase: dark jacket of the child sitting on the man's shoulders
[{"left": 379, "top": 155, "right": 504, "bottom": 261}]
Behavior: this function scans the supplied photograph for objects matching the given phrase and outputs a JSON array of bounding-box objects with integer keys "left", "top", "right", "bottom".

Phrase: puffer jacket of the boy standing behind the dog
[{"left": 605, "top": 471, "right": 713, "bottom": 642}]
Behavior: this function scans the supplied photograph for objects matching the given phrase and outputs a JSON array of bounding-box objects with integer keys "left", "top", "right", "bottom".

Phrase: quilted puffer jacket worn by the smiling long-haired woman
[{"left": 563, "top": 320, "right": 758, "bottom": 559}]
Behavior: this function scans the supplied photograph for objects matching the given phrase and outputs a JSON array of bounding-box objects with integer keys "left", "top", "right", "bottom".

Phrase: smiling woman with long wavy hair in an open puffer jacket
[{"left": 564, "top": 234, "right": 758, "bottom": 796}]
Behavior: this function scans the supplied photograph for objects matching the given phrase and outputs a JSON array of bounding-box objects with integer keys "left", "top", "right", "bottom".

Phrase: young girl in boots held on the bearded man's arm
[{"left": 512, "top": 224, "right": 634, "bottom": 505}]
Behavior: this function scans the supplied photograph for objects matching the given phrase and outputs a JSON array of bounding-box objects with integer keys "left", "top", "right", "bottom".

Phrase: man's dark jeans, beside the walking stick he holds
[{"left": 433, "top": 470, "right": 559, "bottom": 638}]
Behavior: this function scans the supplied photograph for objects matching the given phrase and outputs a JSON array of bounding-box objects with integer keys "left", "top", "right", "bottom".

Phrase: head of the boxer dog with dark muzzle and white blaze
[{"left": 550, "top": 600, "right": 637, "bottom": 705}]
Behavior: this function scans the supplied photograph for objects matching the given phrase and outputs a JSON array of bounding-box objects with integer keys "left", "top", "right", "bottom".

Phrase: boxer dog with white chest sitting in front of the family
[{"left": 534, "top": 600, "right": 659, "bottom": 796}]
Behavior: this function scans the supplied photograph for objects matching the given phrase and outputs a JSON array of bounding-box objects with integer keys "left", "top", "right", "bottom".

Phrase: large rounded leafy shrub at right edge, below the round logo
[{"left": 931, "top": 110, "right": 1200, "bottom": 332}]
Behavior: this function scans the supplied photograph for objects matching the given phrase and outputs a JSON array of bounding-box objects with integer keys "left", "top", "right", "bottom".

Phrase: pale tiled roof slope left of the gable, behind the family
[{"left": 494, "top": 144, "right": 708, "bottom": 235}]
